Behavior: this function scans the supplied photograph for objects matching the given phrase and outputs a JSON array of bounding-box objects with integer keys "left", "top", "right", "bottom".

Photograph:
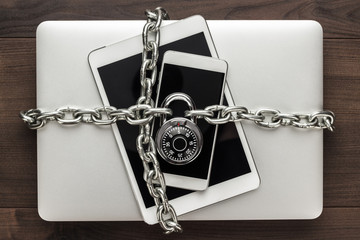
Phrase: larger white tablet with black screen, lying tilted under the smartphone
[{"left": 88, "top": 16, "right": 260, "bottom": 224}]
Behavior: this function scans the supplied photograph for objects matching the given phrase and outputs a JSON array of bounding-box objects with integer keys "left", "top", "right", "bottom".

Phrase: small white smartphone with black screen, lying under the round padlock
[{"left": 153, "top": 51, "right": 227, "bottom": 190}]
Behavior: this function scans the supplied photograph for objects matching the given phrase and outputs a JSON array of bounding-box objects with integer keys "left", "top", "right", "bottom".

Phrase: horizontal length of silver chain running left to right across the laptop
[{"left": 20, "top": 104, "right": 335, "bottom": 131}]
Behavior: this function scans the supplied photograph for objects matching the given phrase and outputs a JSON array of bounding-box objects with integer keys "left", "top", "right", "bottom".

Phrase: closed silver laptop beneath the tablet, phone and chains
[{"left": 36, "top": 20, "right": 323, "bottom": 221}]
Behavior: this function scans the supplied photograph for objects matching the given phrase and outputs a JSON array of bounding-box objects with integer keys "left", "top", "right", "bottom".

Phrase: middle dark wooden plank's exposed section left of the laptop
[{"left": 0, "top": 39, "right": 37, "bottom": 207}]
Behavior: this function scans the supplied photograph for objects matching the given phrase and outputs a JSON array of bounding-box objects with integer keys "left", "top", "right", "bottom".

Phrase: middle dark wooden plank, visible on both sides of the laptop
[{"left": 0, "top": 35, "right": 360, "bottom": 207}]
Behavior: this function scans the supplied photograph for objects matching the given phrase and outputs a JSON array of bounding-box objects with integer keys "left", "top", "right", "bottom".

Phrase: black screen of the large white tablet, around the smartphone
[{"left": 98, "top": 32, "right": 251, "bottom": 208}]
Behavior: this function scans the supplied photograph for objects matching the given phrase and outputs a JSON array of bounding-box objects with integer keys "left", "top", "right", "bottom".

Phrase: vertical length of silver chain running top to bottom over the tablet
[{"left": 135, "top": 7, "right": 182, "bottom": 234}]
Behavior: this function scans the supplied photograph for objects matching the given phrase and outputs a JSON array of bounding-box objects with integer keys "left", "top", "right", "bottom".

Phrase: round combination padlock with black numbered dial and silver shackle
[{"left": 156, "top": 93, "right": 203, "bottom": 165}]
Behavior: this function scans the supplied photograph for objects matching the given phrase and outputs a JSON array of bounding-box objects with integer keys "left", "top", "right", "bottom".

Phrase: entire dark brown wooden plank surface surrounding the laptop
[{"left": 0, "top": 0, "right": 360, "bottom": 240}]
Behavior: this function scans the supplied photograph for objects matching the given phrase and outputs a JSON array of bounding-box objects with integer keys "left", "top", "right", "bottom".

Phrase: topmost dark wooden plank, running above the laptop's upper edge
[{"left": 0, "top": 0, "right": 360, "bottom": 38}]
